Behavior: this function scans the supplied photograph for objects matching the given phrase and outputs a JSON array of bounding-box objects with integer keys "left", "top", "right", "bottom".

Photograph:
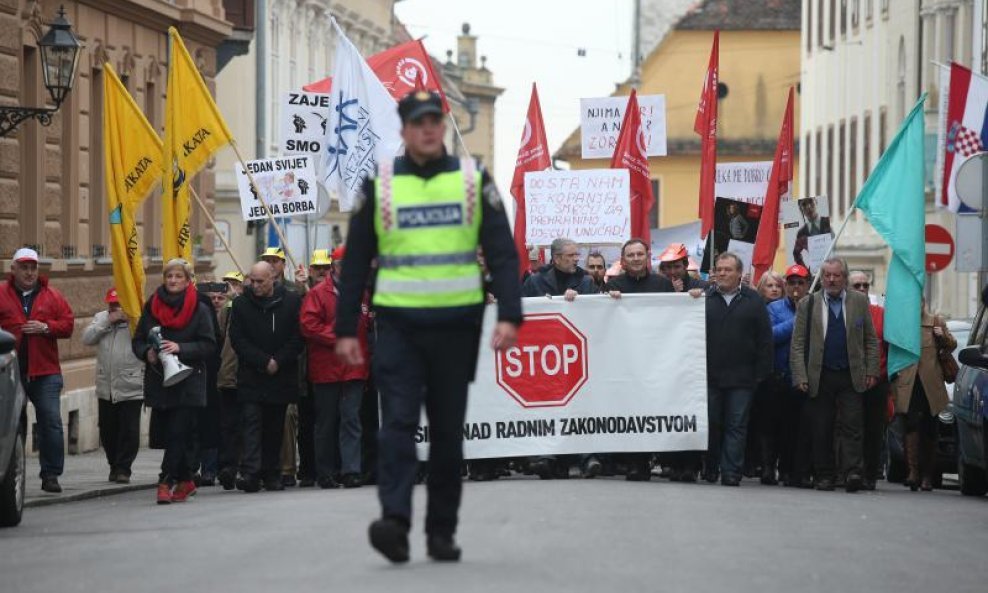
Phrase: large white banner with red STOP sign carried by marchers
[{"left": 415, "top": 294, "right": 708, "bottom": 459}]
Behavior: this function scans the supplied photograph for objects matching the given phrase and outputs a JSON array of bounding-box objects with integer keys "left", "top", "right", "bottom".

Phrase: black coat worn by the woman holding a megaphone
[{"left": 131, "top": 299, "right": 217, "bottom": 410}]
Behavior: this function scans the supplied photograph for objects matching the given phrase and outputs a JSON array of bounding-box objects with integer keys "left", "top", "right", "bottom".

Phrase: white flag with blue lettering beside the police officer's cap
[{"left": 320, "top": 19, "right": 402, "bottom": 212}]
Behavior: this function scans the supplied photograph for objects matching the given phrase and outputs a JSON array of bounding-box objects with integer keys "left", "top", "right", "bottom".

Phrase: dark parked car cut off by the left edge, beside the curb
[{"left": 0, "top": 330, "right": 27, "bottom": 527}]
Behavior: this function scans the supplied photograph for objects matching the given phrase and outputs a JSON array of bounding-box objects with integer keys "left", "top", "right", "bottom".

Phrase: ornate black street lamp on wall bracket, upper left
[{"left": 0, "top": 6, "right": 82, "bottom": 137}]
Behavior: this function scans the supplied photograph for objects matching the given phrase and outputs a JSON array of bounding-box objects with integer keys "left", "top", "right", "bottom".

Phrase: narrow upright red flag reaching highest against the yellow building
[{"left": 693, "top": 31, "right": 720, "bottom": 237}]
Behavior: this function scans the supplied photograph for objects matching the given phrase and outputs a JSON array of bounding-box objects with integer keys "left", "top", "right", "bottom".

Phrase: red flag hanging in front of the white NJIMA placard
[{"left": 611, "top": 89, "right": 655, "bottom": 245}]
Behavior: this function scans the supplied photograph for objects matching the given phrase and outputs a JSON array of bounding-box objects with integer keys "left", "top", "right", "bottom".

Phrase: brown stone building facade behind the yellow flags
[{"left": 0, "top": 0, "right": 233, "bottom": 452}]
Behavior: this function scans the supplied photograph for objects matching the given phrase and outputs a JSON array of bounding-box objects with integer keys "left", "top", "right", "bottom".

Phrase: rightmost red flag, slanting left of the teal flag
[{"left": 751, "top": 87, "right": 793, "bottom": 286}]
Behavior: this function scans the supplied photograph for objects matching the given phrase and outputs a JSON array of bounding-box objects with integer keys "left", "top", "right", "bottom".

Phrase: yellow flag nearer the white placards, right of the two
[{"left": 167, "top": 27, "right": 232, "bottom": 263}]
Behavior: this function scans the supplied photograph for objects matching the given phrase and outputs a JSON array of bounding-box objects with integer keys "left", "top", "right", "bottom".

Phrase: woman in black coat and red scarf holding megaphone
[{"left": 132, "top": 259, "right": 216, "bottom": 504}]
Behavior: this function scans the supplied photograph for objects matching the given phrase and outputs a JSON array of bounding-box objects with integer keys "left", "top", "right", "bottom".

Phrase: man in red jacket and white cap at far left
[{"left": 0, "top": 247, "right": 75, "bottom": 493}]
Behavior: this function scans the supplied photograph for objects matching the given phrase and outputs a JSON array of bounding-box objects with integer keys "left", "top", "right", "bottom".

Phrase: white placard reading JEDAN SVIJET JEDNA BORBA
[{"left": 233, "top": 155, "right": 316, "bottom": 220}]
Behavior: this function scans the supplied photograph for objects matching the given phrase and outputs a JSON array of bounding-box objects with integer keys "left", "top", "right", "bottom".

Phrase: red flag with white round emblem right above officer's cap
[{"left": 302, "top": 39, "right": 449, "bottom": 112}]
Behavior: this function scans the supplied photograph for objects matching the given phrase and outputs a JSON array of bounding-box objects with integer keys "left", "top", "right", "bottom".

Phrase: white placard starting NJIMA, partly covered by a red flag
[{"left": 580, "top": 95, "right": 666, "bottom": 159}]
